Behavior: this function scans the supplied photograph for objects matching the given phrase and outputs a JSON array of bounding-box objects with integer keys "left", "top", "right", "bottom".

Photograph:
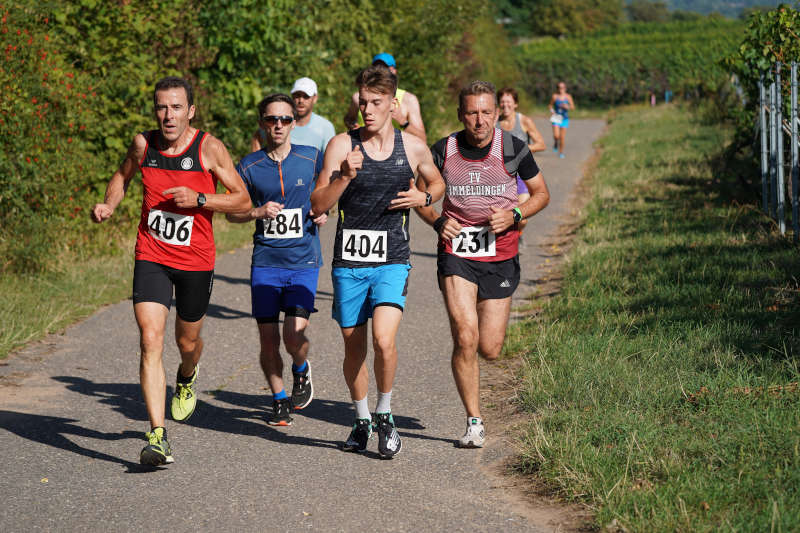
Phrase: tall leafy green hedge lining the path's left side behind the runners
[{"left": 0, "top": 0, "right": 515, "bottom": 272}]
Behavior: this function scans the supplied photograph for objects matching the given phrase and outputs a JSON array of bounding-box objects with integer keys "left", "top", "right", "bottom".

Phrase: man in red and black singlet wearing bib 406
[{"left": 91, "top": 77, "right": 250, "bottom": 465}]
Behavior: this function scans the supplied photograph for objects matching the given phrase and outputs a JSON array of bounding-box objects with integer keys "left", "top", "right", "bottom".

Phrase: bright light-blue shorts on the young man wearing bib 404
[{"left": 331, "top": 264, "right": 411, "bottom": 328}]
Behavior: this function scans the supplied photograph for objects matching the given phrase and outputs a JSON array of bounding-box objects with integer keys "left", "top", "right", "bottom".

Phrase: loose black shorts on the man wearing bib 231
[{"left": 436, "top": 252, "right": 519, "bottom": 300}]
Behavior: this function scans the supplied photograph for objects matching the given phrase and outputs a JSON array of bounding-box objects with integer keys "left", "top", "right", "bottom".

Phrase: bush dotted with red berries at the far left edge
[{"left": 0, "top": 1, "right": 101, "bottom": 272}]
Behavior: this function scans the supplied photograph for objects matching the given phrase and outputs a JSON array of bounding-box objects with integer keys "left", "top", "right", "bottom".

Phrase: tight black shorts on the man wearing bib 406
[{"left": 133, "top": 261, "right": 214, "bottom": 322}]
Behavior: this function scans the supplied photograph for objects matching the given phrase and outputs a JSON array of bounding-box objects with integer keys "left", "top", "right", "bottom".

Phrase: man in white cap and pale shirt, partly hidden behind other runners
[{"left": 250, "top": 78, "right": 336, "bottom": 153}]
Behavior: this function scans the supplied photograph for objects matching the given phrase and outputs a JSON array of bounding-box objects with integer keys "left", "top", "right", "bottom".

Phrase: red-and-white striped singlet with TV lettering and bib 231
[{"left": 439, "top": 128, "right": 519, "bottom": 261}]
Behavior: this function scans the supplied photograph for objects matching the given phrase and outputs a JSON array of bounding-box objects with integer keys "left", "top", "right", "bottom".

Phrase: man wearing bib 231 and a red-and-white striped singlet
[{"left": 417, "top": 81, "right": 550, "bottom": 448}]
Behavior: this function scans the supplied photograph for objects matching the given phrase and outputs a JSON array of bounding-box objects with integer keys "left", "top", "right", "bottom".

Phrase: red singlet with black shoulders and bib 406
[{"left": 136, "top": 130, "right": 217, "bottom": 271}]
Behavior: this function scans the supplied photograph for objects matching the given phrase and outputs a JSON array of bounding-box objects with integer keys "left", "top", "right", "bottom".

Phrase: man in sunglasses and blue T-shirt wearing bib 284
[{"left": 227, "top": 93, "right": 328, "bottom": 426}]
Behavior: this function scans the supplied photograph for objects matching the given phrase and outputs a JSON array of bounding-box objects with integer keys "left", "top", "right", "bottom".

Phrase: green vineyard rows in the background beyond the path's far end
[{"left": 517, "top": 17, "right": 744, "bottom": 105}]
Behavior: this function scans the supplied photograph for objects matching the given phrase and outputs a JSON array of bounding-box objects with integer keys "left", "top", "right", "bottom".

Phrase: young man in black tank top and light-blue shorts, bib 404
[{"left": 311, "top": 65, "right": 444, "bottom": 458}]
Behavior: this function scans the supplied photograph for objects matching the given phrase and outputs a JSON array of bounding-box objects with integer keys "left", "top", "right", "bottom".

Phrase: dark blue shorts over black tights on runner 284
[{"left": 250, "top": 266, "right": 319, "bottom": 322}]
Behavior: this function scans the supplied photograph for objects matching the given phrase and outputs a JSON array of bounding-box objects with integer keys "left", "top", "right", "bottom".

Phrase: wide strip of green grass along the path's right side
[{"left": 506, "top": 106, "right": 800, "bottom": 531}]
